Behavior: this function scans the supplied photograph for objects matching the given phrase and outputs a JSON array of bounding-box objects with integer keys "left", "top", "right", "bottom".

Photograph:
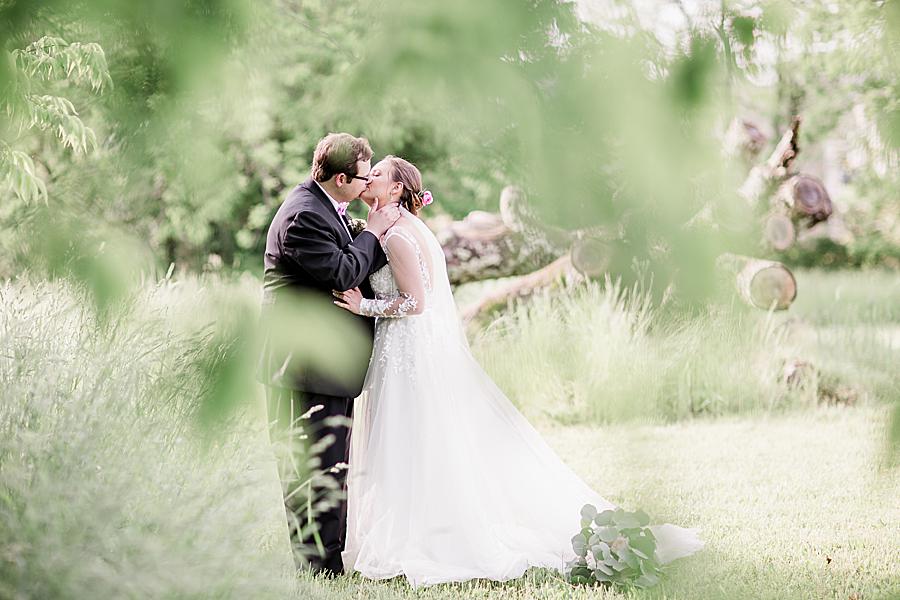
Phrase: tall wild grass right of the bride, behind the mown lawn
[{"left": 472, "top": 272, "right": 900, "bottom": 423}]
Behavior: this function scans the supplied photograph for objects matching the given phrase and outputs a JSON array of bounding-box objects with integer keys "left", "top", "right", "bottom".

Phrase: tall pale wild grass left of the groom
[{"left": 0, "top": 282, "right": 297, "bottom": 598}]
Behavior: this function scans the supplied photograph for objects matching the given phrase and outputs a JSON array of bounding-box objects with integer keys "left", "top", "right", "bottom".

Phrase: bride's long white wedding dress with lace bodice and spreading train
[{"left": 342, "top": 211, "right": 703, "bottom": 587}]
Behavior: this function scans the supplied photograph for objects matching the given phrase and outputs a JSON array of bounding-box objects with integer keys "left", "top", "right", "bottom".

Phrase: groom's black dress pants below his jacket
[{"left": 266, "top": 387, "right": 353, "bottom": 574}]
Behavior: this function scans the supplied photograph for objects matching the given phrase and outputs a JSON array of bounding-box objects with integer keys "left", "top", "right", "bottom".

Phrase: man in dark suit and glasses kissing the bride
[{"left": 259, "top": 133, "right": 400, "bottom": 573}]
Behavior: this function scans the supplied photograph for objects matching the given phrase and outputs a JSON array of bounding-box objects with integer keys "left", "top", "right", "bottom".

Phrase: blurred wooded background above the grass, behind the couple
[{"left": 0, "top": 0, "right": 900, "bottom": 310}]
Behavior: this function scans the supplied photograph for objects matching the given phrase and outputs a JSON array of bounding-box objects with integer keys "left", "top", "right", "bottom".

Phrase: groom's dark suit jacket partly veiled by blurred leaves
[{"left": 257, "top": 179, "right": 387, "bottom": 398}]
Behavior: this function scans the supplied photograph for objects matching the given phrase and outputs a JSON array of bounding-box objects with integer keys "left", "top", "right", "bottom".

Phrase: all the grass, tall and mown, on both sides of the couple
[{"left": 0, "top": 272, "right": 900, "bottom": 600}]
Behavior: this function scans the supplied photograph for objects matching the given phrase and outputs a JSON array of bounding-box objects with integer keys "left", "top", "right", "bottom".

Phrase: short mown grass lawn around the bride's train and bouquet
[{"left": 302, "top": 408, "right": 900, "bottom": 600}]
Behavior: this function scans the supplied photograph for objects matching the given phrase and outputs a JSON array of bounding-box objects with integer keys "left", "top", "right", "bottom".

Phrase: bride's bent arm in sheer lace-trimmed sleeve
[{"left": 359, "top": 226, "right": 425, "bottom": 317}]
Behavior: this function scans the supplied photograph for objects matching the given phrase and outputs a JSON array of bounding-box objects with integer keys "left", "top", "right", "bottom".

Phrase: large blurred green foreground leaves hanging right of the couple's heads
[{"left": 346, "top": 0, "right": 755, "bottom": 301}]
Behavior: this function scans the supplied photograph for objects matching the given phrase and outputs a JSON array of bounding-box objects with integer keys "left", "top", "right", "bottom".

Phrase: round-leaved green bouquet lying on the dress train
[{"left": 567, "top": 504, "right": 662, "bottom": 588}]
